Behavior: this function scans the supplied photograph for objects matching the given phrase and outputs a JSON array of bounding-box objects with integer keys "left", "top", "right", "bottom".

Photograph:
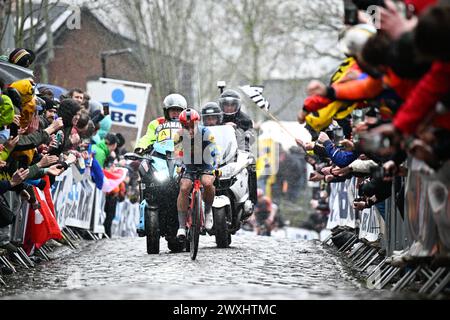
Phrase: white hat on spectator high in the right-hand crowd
[{"left": 338, "top": 24, "right": 377, "bottom": 57}]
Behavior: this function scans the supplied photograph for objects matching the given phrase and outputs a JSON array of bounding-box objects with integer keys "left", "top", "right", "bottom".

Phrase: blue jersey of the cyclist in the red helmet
[{"left": 174, "top": 126, "right": 219, "bottom": 170}]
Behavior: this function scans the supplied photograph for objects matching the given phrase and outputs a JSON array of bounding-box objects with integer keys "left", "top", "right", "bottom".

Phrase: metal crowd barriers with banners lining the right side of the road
[{"left": 326, "top": 159, "right": 450, "bottom": 296}]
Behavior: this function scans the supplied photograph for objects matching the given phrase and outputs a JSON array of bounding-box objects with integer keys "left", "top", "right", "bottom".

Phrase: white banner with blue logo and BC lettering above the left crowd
[{"left": 87, "top": 78, "right": 152, "bottom": 138}]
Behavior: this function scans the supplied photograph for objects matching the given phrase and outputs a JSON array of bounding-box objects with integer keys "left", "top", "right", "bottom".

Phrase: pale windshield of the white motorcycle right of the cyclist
[{"left": 208, "top": 125, "right": 238, "bottom": 166}]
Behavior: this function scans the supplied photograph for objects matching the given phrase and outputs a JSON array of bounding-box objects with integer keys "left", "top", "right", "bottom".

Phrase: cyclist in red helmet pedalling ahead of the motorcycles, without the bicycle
[{"left": 174, "top": 109, "right": 218, "bottom": 241}]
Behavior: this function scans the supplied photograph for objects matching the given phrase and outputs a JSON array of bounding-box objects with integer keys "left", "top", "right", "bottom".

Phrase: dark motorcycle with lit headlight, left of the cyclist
[{"left": 125, "top": 122, "right": 185, "bottom": 254}]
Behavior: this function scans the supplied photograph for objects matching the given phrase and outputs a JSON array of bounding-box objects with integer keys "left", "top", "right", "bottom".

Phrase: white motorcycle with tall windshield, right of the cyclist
[{"left": 208, "top": 125, "right": 255, "bottom": 248}]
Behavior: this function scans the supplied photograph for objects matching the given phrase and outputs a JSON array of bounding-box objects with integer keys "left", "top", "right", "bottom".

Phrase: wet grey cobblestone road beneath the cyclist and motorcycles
[{"left": 0, "top": 234, "right": 414, "bottom": 300}]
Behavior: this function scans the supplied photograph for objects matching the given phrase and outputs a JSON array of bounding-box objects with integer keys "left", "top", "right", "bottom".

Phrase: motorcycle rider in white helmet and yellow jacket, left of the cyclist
[{"left": 135, "top": 93, "right": 187, "bottom": 154}]
